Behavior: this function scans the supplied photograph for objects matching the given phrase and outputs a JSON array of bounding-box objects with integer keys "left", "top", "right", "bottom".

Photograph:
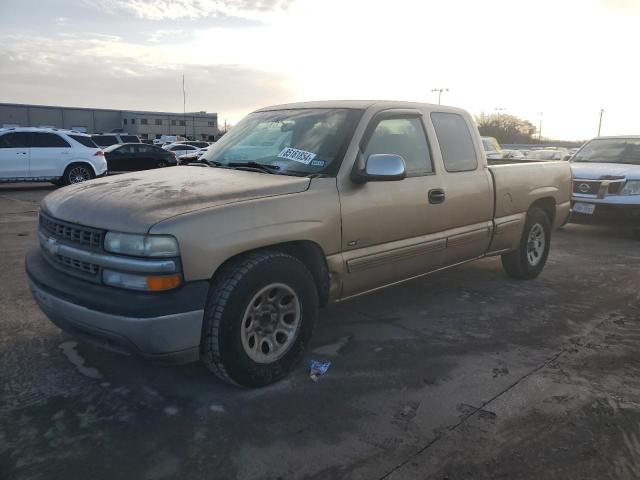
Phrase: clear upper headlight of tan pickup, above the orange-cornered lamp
[{"left": 104, "top": 232, "right": 180, "bottom": 257}]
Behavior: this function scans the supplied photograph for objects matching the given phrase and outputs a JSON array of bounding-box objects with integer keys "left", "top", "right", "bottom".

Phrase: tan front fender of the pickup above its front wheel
[{"left": 149, "top": 178, "right": 341, "bottom": 281}]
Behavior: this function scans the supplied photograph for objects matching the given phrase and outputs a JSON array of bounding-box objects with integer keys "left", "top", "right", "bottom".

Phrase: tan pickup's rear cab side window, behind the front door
[{"left": 431, "top": 112, "right": 478, "bottom": 172}]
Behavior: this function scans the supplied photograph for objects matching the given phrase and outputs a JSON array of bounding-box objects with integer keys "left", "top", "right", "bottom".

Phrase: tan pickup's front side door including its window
[{"left": 338, "top": 110, "right": 446, "bottom": 298}]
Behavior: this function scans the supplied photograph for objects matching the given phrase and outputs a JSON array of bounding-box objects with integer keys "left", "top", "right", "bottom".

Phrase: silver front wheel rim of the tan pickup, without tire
[{"left": 240, "top": 283, "right": 301, "bottom": 363}]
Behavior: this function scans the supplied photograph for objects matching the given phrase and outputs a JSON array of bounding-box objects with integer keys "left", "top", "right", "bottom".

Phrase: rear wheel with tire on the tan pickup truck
[{"left": 502, "top": 207, "right": 551, "bottom": 280}]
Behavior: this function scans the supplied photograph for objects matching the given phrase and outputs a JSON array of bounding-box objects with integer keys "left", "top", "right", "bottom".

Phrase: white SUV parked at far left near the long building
[{"left": 0, "top": 127, "right": 107, "bottom": 185}]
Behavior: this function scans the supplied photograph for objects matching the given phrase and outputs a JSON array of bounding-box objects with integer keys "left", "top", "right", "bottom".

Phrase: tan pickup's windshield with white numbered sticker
[{"left": 202, "top": 109, "right": 361, "bottom": 175}]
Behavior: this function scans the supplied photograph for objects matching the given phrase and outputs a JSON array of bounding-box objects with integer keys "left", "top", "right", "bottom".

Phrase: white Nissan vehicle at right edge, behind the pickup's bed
[{"left": 570, "top": 136, "right": 640, "bottom": 239}]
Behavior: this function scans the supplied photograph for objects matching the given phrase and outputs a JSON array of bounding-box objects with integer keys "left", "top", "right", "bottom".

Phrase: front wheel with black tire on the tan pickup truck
[{"left": 200, "top": 251, "right": 318, "bottom": 388}]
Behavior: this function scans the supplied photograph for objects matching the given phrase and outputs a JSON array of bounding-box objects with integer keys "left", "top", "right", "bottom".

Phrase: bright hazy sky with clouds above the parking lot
[{"left": 0, "top": 0, "right": 640, "bottom": 140}]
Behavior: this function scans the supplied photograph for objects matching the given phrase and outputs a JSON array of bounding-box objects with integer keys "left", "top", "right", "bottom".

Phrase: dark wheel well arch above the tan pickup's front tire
[{"left": 211, "top": 240, "right": 329, "bottom": 306}]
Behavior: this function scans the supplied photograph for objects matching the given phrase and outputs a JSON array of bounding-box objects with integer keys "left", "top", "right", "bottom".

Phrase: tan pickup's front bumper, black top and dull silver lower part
[{"left": 26, "top": 249, "right": 209, "bottom": 363}]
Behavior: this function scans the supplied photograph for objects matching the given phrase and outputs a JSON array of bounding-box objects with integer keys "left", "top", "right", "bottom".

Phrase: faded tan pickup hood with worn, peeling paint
[{"left": 41, "top": 167, "right": 310, "bottom": 233}]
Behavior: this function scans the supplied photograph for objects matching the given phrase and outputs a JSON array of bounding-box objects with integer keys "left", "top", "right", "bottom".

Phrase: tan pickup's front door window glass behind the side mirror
[{"left": 364, "top": 118, "right": 433, "bottom": 176}]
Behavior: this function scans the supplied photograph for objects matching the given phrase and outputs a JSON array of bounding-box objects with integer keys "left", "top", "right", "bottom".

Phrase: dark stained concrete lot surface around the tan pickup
[{"left": 0, "top": 185, "right": 640, "bottom": 479}]
